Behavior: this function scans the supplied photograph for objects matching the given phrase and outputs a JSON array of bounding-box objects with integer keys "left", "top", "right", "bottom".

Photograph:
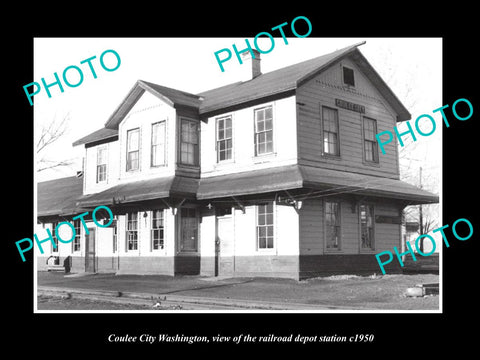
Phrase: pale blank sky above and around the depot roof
[{"left": 33, "top": 37, "right": 444, "bottom": 193}]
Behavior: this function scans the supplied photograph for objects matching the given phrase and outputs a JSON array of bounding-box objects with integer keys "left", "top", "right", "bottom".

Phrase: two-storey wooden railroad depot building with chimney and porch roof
[{"left": 35, "top": 44, "right": 438, "bottom": 279}]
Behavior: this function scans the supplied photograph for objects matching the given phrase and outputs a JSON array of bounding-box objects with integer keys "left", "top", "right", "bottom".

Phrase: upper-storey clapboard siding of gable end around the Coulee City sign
[{"left": 297, "top": 60, "right": 399, "bottom": 178}]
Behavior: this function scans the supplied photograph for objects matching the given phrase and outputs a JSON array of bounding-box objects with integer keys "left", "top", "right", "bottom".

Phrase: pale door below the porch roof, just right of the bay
[{"left": 217, "top": 216, "right": 235, "bottom": 276}]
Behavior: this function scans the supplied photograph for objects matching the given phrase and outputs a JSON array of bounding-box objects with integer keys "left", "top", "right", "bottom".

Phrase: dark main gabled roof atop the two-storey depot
[{"left": 74, "top": 42, "right": 411, "bottom": 145}]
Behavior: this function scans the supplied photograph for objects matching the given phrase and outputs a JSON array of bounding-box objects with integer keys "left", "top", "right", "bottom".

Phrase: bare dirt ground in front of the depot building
[{"left": 38, "top": 272, "right": 442, "bottom": 310}]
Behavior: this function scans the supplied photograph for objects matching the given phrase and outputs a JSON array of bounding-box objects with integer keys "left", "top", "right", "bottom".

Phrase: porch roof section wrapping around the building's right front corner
[{"left": 197, "top": 165, "right": 439, "bottom": 204}]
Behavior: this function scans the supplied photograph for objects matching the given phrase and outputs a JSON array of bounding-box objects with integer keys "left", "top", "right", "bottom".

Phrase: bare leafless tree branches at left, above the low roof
[{"left": 36, "top": 114, "right": 74, "bottom": 172}]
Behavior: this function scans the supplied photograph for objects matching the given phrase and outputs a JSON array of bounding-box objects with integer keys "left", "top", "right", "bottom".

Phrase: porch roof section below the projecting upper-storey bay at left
[{"left": 77, "top": 176, "right": 198, "bottom": 208}]
